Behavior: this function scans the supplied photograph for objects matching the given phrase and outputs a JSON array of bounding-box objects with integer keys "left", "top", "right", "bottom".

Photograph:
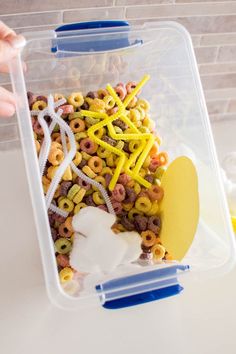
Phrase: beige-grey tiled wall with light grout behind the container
[{"left": 0, "top": 0, "right": 236, "bottom": 148}]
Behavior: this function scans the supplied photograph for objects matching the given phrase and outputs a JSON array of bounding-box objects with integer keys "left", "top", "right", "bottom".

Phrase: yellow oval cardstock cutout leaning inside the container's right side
[{"left": 160, "top": 156, "right": 199, "bottom": 261}]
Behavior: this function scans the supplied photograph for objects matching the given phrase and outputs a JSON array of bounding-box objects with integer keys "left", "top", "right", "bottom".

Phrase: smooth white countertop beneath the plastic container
[{"left": 0, "top": 119, "right": 236, "bottom": 354}]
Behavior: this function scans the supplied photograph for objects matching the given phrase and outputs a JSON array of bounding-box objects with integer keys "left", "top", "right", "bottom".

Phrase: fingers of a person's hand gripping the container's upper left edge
[{"left": 0, "top": 21, "right": 25, "bottom": 117}]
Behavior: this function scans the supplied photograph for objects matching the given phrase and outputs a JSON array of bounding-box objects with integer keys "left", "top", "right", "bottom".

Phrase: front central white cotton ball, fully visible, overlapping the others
[{"left": 85, "top": 229, "right": 128, "bottom": 273}]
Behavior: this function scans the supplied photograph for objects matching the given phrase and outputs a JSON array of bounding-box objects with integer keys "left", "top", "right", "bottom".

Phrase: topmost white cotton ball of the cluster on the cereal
[{"left": 72, "top": 206, "right": 116, "bottom": 236}]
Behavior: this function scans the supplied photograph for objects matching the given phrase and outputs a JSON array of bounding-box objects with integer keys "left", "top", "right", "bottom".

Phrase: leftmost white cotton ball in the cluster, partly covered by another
[{"left": 70, "top": 234, "right": 100, "bottom": 273}]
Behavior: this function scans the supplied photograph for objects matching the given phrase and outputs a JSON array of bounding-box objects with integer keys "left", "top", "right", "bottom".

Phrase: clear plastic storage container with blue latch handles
[{"left": 11, "top": 22, "right": 235, "bottom": 309}]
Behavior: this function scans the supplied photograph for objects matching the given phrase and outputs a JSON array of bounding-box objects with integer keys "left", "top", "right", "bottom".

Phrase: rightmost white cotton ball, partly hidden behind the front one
[{"left": 117, "top": 231, "right": 142, "bottom": 264}]
